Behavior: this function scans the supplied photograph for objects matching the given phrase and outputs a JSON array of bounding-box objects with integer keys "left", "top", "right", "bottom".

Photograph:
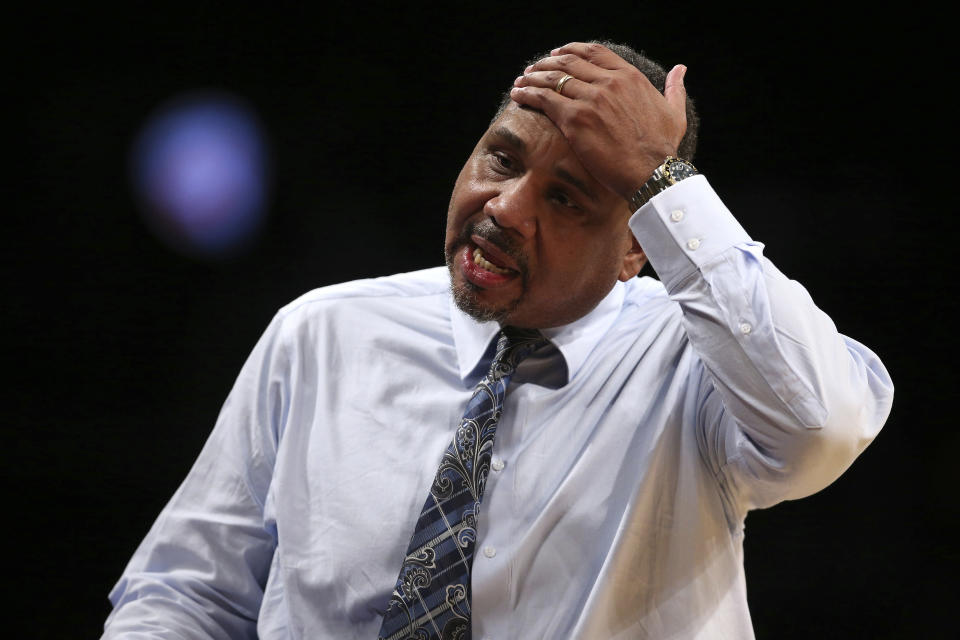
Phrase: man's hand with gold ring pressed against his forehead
[{"left": 510, "top": 42, "right": 687, "bottom": 199}]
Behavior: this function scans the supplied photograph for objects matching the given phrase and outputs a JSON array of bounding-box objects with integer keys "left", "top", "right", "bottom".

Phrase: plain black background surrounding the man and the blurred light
[{"left": 2, "top": 2, "right": 958, "bottom": 639}]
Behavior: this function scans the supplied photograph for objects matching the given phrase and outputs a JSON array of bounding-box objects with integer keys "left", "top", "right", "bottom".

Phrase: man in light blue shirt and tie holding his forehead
[{"left": 105, "top": 43, "right": 892, "bottom": 638}]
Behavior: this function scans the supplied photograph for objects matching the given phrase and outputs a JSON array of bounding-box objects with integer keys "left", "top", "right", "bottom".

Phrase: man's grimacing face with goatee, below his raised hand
[{"left": 445, "top": 103, "right": 643, "bottom": 329}]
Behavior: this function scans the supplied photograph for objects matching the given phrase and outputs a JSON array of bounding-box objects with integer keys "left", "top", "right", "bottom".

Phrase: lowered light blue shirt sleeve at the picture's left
[{"left": 103, "top": 312, "right": 287, "bottom": 639}]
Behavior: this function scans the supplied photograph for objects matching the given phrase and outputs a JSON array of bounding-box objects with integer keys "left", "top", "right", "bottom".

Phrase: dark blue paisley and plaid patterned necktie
[{"left": 379, "top": 327, "right": 547, "bottom": 640}]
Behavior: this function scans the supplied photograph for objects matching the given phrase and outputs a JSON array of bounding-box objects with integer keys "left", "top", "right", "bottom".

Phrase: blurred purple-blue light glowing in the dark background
[{"left": 131, "top": 94, "right": 268, "bottom": 256}]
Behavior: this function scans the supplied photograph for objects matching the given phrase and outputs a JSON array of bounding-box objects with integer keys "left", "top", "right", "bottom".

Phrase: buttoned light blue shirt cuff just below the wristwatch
[{"left": 629, "top": 175, "right": 751, "bottom": 292}]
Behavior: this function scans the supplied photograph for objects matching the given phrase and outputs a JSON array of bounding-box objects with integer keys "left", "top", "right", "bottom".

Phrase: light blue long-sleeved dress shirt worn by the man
[{"left": 104, "top": 176, "right": 893, "bottom": 640}]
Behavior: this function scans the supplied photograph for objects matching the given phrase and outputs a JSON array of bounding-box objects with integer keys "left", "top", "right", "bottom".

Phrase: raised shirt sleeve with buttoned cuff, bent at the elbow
[{"left": 630, "top": 176, "right": 893, "bottom": 513}]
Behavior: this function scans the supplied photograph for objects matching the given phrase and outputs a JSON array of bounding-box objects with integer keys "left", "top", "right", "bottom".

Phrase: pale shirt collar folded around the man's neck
[{"left": 450, "top": 281, "right": 625, "bottom": 383}]
